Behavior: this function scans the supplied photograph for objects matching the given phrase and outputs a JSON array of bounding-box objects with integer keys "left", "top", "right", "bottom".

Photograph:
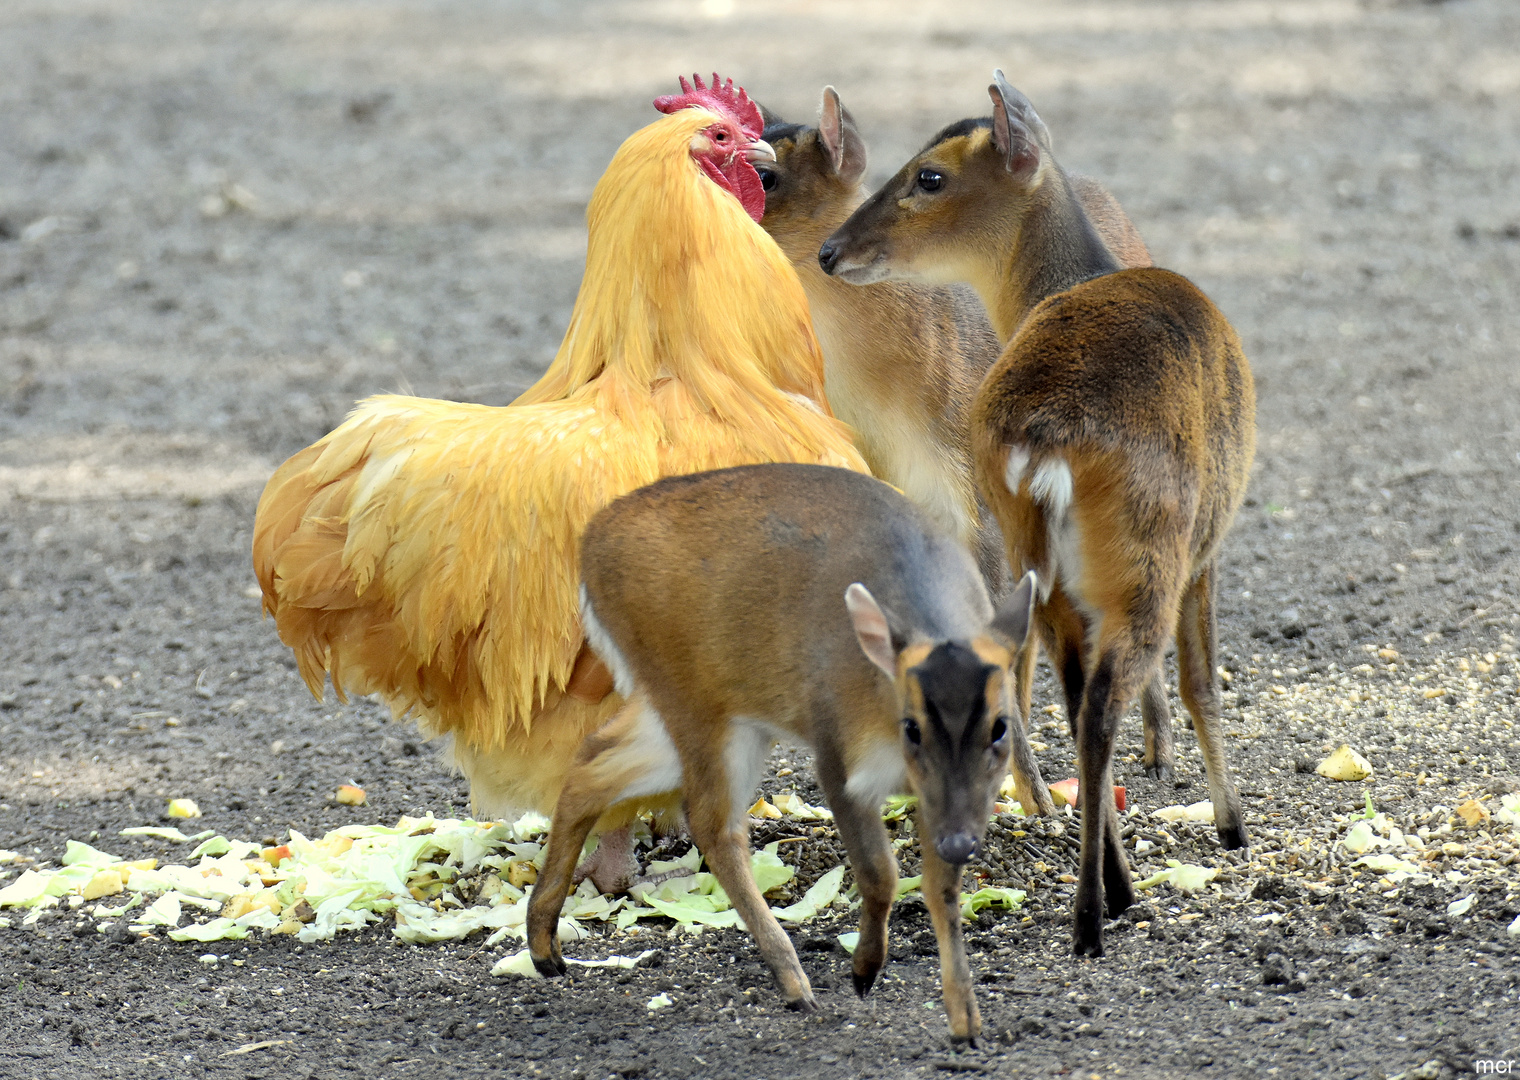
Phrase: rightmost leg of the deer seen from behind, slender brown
[{"left": 1176, "top": 564, "right": 1249, "bottom": 848}]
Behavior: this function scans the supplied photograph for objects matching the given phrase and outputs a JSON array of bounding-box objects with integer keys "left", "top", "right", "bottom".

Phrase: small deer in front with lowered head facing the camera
[{"left": 527, "top": 465, "right": 1035, "bottom": 1039}]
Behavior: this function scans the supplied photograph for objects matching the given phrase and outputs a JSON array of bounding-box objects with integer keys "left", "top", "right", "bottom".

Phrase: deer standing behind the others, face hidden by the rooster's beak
[{"left": 755, "top": 87, "right": 1172, "bottom": 814}]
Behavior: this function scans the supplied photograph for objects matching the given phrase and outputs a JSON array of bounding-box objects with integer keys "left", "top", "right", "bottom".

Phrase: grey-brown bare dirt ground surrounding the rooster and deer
[{"left": 0, "top": 0, "right": 1520, "bottom": 1080}]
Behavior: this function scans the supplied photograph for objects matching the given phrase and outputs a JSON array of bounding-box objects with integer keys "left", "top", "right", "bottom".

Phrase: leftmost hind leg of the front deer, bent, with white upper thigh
[{"left": 527, "top": 696, "right": 681, "bottom": 975}]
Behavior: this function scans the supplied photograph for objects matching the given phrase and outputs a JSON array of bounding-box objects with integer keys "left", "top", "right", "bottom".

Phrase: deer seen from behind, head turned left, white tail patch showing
[{"left": 819, "top": 71, "right": 1256, "bottom": 955}]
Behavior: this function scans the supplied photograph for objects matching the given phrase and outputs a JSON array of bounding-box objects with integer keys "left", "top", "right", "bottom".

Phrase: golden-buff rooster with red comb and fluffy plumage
[{"left": 254, "top": 74, "right": 866, "bottom": 887}]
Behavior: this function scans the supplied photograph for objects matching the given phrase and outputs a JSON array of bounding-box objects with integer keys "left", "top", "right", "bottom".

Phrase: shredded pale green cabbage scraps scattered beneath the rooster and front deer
[{"left": 0, "top": 794, "right": 997, "bottom": 945}]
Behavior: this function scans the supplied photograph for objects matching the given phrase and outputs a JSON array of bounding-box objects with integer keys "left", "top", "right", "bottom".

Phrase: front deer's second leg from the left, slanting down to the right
[{"left": 684, "top": 738, "right": 818, "bottom": 1012}]
